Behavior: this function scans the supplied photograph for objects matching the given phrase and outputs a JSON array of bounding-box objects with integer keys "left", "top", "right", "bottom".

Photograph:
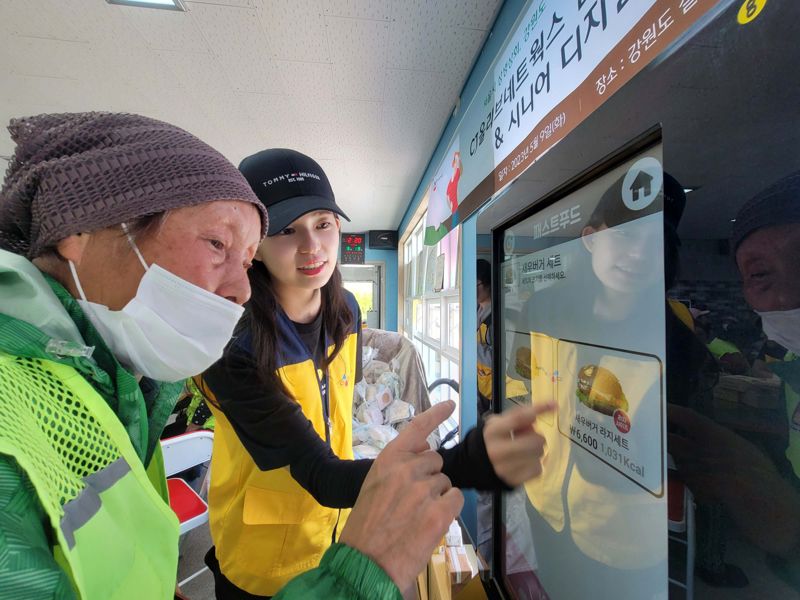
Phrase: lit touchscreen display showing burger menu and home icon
[{"left": 495, "top": 145, "right": 664, "bottom": 600}]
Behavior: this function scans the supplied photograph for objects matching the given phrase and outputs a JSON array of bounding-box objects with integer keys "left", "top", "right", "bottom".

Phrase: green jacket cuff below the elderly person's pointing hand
[{"left": 275, "top": 544, "right": 403, "bottom": 600}]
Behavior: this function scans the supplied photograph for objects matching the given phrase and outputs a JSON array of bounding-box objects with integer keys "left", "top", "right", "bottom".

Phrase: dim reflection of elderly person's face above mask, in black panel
[{"left": 736, "top": 223, "right": 800, "bottom": 312}]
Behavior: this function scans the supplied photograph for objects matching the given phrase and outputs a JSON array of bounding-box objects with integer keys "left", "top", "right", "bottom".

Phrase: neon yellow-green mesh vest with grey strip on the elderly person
[{"left": 0, "top": 352, "right": 178, "bottom": 600}]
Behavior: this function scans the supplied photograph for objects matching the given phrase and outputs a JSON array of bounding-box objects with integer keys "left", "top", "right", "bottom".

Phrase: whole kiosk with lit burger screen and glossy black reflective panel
[{"left": 478, "top": 1, "right": 800, "bottom": 600}]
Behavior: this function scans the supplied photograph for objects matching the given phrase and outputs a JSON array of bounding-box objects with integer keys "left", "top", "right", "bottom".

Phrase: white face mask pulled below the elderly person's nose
[{"left": 69, "top": 224, "right": 244, "bottom": 382}]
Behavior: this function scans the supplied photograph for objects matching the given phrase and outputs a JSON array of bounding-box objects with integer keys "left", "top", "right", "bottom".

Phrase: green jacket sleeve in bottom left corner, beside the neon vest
[{"left": 0, "top": 455, "right": 75, "bottom": 600}]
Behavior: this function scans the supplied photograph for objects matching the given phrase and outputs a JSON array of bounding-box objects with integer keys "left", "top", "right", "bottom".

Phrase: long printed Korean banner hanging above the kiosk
[{"left": 425, "top": 0, "right": 717, "bottom": 244}]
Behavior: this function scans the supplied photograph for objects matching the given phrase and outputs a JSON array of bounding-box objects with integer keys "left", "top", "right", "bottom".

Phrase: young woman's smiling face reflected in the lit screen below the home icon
[{"left": 582, "top": 222, "right": 661, "bottom": 294}]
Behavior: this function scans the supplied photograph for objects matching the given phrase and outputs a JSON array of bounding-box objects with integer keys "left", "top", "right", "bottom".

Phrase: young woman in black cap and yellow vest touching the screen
[{"left": 198, "top": 149, "right": 542, "bottom": 598}]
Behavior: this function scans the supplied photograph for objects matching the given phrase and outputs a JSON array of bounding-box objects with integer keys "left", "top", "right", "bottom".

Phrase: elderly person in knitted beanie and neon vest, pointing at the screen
[{"left": 0, "top": 113, "right": 461, "bottom": 599}]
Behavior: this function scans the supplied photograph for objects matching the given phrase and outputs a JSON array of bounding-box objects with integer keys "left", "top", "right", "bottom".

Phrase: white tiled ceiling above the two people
[{"left": 0, "top": 0, "right": 502, "bottom": 231}]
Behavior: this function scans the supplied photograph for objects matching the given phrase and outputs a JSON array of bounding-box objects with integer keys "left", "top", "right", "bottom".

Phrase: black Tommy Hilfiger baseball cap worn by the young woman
[{"left": 239, "top": 148, "right": 350, "bottom": 236}]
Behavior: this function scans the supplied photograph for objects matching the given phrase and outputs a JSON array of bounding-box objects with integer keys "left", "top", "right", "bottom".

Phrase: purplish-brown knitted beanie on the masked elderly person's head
[{"left": 0, "top": 113, "right": 268, "bottom": 259}]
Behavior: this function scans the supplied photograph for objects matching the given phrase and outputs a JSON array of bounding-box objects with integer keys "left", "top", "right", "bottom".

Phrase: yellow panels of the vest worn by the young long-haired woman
[{"left": 199, "top": 312, "right": 360, "bottom": 596}]
